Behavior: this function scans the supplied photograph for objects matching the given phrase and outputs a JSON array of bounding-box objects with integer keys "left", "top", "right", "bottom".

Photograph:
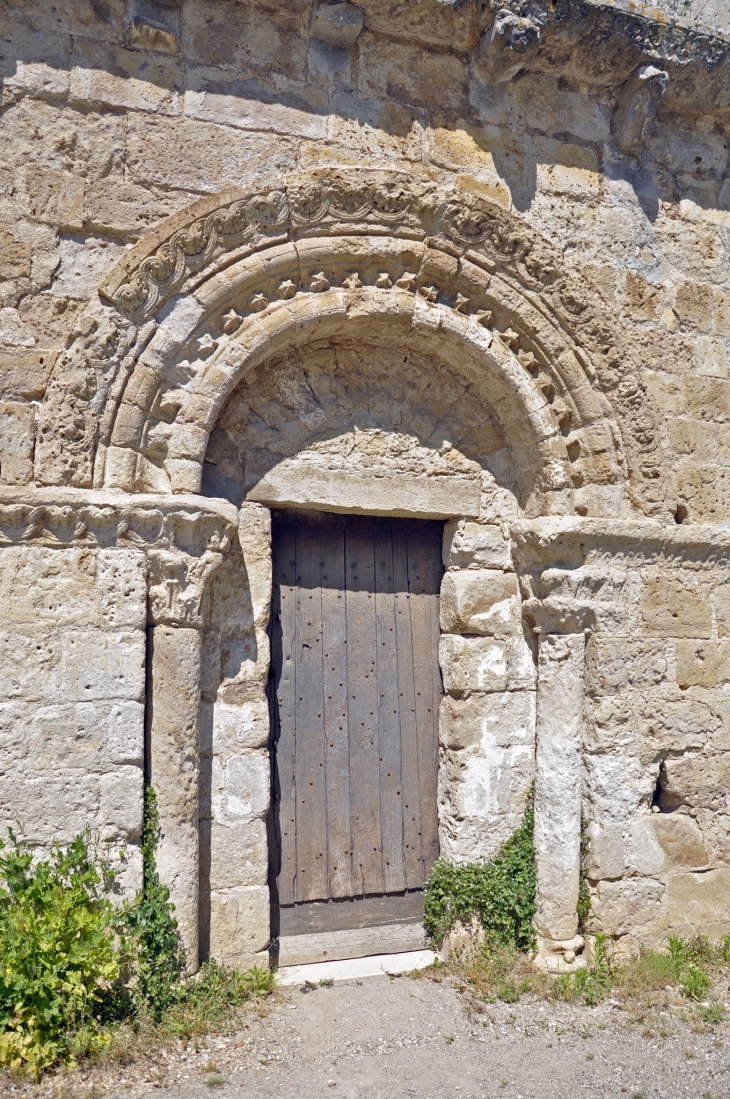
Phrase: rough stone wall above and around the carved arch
[{"left": 0, "top": 0, "right": 730, "bottom": 521}]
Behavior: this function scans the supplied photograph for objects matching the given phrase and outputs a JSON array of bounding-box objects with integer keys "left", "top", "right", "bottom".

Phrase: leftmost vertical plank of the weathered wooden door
[{"left": 272, "top": 512, "right": 297, "bottom": 904}]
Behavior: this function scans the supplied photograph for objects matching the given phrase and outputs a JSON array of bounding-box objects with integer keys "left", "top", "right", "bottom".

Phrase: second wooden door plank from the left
[{"left": 295, "top": 512, "right": 328, "bottom": 901}]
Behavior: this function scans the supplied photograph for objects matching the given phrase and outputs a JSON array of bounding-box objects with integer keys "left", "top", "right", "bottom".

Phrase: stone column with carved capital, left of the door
[{"left": 146, "top": 550, "right": 223, "bottom": 973}]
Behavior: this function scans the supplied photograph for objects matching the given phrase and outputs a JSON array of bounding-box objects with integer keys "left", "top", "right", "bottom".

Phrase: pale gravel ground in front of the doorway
[{"left": 5, "top": 977, "right": 730, "bottom": 1099}]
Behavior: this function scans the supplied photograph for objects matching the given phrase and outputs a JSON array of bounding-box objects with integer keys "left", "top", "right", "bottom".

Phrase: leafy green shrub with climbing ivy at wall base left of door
[{"left": 0, "top": 787, "right": 273, "bottom": 1078}]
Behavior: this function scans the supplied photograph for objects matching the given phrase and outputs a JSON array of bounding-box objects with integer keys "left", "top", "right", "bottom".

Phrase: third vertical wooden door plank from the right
[{"left": 374, "top": 519, "right": 406, "bottom": 892}]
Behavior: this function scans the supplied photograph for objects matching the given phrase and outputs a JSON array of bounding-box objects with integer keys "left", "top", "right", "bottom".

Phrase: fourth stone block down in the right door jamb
[{"left": 439, "top": 691, "right": 535, "bottom": 751}]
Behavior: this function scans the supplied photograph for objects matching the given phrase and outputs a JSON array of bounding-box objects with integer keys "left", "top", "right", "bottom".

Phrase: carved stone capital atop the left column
[{"left": 147, "top": 550, "right": 223, "bottom": 626}]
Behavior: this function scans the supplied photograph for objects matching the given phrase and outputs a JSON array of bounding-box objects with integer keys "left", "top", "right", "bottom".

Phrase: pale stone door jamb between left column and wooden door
[{"left": 200, "top": 503, "right": 272, "bottom": 968}]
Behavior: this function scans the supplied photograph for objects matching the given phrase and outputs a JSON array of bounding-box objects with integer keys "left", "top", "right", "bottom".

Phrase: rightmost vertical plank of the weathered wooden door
[{"left": 407, "top": 521, "right": 440, "bottom": 879}]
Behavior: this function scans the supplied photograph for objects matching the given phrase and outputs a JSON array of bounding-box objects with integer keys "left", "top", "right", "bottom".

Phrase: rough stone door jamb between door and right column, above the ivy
[{"left": 439, "top": 509, "right": 537, "bottom": 862}]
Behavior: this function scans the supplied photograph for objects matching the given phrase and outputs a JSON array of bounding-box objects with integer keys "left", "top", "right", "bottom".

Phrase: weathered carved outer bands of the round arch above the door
[{"left": 36, "top": 171, "right": 664, "bottom": 514}]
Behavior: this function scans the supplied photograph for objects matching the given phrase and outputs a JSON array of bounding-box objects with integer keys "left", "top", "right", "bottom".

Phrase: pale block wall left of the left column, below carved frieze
[{"left": 0, "top": 531, "right": 146, "bottom": 888}]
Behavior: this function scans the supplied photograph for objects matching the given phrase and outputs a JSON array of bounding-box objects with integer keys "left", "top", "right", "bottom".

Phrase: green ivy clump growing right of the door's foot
[{"left": 424, "top": 795, "right": 535, "bottom": 952}]
